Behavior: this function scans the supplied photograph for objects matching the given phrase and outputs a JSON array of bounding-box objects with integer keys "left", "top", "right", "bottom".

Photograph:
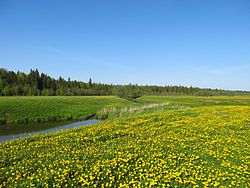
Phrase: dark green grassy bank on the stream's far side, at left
[{"left": 0, "top": 96, "right": 137, "bottom": 124}]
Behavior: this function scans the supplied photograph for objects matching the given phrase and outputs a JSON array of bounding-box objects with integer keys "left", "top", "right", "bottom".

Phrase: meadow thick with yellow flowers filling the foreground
[{"left": 0, "top": 106, "right": 250, "bottom": 187}]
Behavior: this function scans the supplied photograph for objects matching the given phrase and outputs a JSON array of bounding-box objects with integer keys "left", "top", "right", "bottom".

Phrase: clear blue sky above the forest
[{"left": 0, "top": 0, "right": 250, "bottom": 91}]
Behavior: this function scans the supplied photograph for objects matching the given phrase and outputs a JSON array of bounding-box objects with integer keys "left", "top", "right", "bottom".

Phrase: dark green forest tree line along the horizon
[{"left": 0, "top": 68, "right": 250, "bottom": 99}]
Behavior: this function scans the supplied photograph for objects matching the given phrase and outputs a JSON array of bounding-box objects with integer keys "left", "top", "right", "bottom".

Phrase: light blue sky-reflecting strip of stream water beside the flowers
[{"left": 0, "top": 119, "right": 101, "bottom": 142}]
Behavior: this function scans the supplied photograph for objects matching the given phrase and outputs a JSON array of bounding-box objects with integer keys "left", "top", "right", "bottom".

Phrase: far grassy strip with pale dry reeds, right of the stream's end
[{"left": 98, "top": 95, "right": 250, "bottom": 119}]
